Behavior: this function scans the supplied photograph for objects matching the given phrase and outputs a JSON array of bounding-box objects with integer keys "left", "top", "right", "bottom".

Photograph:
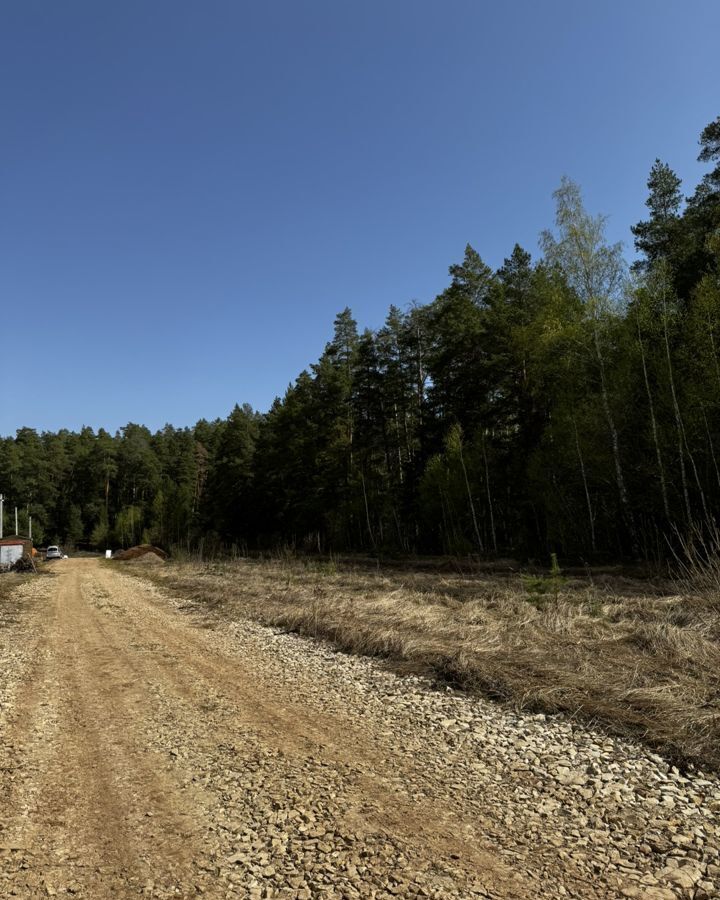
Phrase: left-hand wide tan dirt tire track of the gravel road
[{"left": 3, "top": 569, "right": 222, "bottom": 898}]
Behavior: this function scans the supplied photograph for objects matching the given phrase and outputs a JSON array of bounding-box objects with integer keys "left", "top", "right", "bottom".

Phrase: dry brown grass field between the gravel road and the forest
[{"left": 138, "top": 560, "right": 720, "bottom": 769}]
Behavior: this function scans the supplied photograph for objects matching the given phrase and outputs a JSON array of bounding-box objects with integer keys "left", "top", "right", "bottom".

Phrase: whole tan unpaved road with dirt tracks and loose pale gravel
[{"left": 0, "top": 560, "right": 720, "bottom": 900}]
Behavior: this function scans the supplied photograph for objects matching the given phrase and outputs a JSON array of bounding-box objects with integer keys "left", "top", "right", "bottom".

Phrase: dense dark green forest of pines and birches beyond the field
[{"left": 0, "top": 117, "right": 720, "bottom": 560}]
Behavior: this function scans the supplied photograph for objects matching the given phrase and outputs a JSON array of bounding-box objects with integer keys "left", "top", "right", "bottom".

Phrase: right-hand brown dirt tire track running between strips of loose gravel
[{"left": 89, "top": 570, "right": 537, "bottom": 898}]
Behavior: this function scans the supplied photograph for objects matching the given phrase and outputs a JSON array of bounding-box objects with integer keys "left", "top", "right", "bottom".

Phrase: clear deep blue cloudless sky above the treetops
[{"left": 0, "top": 0, "right": 720, "bottom": 434}]
